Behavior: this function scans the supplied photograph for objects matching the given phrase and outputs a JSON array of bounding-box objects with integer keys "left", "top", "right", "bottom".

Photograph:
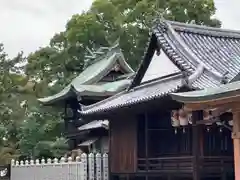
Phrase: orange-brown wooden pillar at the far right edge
[{"left": 232, "top": 107, "right": 240, "bottom": 180}]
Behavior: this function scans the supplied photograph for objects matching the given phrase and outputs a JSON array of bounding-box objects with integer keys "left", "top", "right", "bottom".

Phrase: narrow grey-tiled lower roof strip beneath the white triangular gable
[{"left": 80, "top": 73, "right": 184, "bottom": 115}]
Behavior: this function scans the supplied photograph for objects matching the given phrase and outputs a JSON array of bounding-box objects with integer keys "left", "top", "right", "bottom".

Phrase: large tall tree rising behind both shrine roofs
[{"left": 27, "top": 0, "right": 221, "bottom": 84}]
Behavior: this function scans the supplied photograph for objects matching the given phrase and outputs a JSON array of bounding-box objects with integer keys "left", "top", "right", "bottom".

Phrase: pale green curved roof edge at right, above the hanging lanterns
[{"left": 171, "top": 81, "right": 240, "bottom": 103}]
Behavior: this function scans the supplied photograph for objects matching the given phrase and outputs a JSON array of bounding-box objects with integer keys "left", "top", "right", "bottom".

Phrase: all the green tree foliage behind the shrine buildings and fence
[{"left": 0, "top": 0, "right": 221, "bottom": 163}]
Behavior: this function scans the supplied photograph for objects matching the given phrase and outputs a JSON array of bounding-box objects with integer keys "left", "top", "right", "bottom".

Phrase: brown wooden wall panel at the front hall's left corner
[{"left": 110, "top": 117, "right": 137, "bottom": 173}]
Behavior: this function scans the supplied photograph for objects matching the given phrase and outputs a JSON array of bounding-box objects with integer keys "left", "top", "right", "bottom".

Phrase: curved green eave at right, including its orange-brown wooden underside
[{"left": 170, "top": 81, "right": 240, "bottom": 107}]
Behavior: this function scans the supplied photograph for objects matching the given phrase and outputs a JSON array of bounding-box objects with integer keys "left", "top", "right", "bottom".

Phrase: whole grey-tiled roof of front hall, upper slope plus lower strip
[{"left": 81, "top": 19, "right": 240, "bottom": 115}]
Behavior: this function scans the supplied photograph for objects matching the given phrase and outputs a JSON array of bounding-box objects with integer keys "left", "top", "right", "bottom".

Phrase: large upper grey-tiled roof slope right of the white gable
[{"left": 153, "top": 20, "right": 240, "bottom": 89}]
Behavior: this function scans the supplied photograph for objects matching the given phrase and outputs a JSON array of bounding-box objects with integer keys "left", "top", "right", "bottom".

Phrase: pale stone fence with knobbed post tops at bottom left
[{"left": 11, "top": 153, "right": 108, "bottom": 180}]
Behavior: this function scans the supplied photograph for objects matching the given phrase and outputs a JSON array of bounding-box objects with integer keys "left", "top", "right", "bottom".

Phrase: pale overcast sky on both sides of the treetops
[{"left": 0, "top": 0, "right": 240, "bottom": 56}]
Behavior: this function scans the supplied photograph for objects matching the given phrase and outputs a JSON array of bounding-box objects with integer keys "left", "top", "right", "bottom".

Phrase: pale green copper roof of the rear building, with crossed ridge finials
[{"left": 38, "top": 44, "right": 134, "bottom": 105}]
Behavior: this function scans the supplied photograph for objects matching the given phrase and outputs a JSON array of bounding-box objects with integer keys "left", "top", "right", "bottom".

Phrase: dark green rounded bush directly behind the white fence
[{"left": 17, "top": 107, "right": 68, "bottom": 158}]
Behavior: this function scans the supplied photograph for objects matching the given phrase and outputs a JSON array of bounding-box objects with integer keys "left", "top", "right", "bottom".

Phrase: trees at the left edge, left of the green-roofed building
[{"left": 0, "top": 45, "right": 67, "bottom": 164}]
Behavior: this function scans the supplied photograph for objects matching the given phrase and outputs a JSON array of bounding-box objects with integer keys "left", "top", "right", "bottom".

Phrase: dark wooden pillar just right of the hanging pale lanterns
[{"left": 192, "top": 111, "right": 202, "bottom": 180}]
